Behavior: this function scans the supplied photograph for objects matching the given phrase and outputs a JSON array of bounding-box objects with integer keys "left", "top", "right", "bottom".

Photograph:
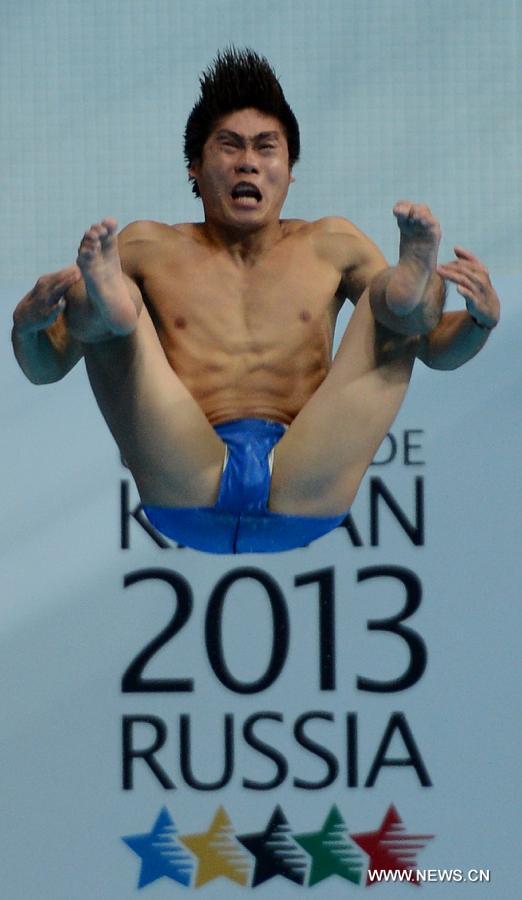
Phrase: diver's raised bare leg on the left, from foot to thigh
[{"left": 69, "top": 220, "right": 225, "bottom": 506}]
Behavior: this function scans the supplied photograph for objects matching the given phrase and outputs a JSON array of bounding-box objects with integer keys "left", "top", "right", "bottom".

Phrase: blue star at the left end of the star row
[{"left": 122, "top": 806, "right": 194, "bottom": 888}]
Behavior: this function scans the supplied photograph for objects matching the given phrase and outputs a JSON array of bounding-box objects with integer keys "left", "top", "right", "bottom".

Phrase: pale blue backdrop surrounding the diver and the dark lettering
[{"left": 0, "top": 0, "right": 522, "bottom": 900}]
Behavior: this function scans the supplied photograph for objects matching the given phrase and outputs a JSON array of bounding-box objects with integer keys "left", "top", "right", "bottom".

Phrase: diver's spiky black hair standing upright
[{"left": 184, "top": 47, "right": 299, "bottom": 197}]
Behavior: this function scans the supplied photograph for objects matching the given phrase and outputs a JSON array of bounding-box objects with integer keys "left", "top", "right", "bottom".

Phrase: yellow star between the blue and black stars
[{"left": 179, "top": 806, "right": 250, "bottom": 887}]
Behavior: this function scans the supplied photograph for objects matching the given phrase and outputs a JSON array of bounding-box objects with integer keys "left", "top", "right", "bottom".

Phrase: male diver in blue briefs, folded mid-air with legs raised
[{"left": 13, "top": 49, "right": 499, "bottom": 553}]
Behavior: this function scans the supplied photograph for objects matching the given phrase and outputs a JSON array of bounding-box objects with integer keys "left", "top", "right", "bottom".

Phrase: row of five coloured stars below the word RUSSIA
[{"left": 122, "top": 805, "right": 434, "bottom": 889}]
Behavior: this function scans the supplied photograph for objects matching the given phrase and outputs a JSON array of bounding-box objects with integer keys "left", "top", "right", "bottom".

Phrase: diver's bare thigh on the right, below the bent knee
[{"left": 269, "top": 291, "right": 417, "bottom": 516}]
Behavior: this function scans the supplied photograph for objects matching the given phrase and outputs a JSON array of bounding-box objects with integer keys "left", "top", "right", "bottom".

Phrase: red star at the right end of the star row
[{"left": 350, "top": 805, "right": 434, "bottom": 885}]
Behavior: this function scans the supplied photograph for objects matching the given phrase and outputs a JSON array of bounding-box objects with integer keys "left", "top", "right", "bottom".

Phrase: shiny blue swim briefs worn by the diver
[{"left": 143, "top": 419, "right": 346, "bottom": 553}]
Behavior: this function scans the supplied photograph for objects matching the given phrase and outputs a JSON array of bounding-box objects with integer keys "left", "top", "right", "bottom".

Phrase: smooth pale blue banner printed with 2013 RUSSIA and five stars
[{"left": 1, "top": 279, "right": 522, "bottom": 900}]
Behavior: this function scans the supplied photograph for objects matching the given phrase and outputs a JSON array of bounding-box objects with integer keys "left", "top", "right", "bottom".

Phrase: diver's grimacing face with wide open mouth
[{"left": 189, "top": 109, "right": 293, "bottom": 229}]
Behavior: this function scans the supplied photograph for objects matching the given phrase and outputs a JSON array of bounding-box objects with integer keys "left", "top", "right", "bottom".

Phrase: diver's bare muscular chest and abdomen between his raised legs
[{"left": 119, "top": 220, "right": 364, "bottom": 424}]
